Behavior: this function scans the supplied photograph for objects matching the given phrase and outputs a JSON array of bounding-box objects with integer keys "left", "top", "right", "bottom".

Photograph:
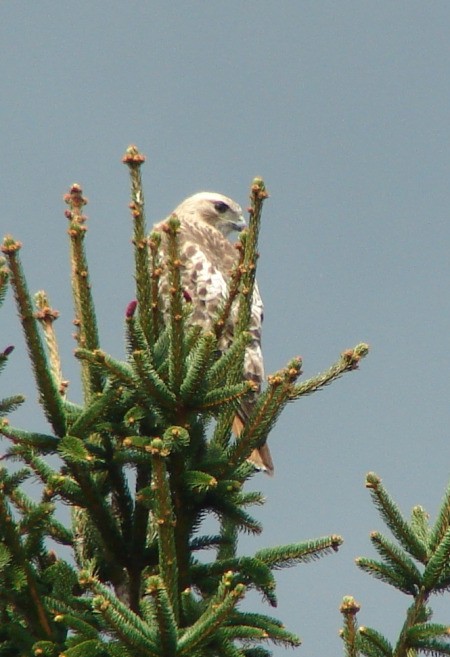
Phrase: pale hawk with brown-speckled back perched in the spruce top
[{"left": 154, "top": 192, "right": 273, "bottom": 474}]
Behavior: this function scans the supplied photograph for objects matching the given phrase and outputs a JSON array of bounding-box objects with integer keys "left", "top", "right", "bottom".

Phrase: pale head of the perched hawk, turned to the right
[{"left": 175, "top": 192, "right": 247, "bottom": 237}]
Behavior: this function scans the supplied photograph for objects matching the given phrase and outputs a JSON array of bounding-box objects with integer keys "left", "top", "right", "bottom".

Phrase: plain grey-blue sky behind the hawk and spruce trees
[{"left": 0, "top": 0, "right": 450, "bottom": 657}]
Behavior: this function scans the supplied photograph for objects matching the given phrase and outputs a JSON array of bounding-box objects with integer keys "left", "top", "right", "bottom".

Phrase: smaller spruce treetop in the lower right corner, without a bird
[{"left": 341, "top": 472, "right": 450, "bottom": 657}]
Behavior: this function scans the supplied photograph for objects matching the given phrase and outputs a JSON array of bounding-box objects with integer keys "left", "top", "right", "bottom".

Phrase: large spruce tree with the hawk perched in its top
[{"left": 0, "top": 147, "right": 372, "bottom": 657}]
